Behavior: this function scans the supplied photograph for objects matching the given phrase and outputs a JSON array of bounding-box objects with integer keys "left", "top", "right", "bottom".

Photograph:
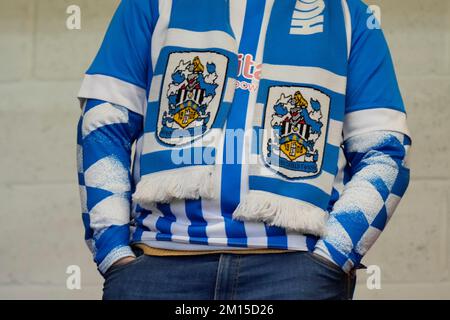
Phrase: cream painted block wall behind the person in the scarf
[{"left": 0, "top": 0, "right": 450, "bottom": 299}]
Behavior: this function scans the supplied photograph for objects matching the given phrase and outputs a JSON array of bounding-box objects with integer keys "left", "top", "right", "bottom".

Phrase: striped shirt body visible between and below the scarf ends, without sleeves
[{"left": 133, "top": 0, "right": 343, "bottom": 250}]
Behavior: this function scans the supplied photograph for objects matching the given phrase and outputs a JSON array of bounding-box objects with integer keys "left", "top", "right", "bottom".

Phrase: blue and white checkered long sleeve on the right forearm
[{"left": 314, "top": 131, "right": 411, "bottom": 272}]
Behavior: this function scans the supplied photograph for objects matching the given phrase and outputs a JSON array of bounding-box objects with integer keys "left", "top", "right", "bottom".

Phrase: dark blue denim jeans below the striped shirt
[{"left": 103, "top": 248, "right": 356, "bottom": 300}]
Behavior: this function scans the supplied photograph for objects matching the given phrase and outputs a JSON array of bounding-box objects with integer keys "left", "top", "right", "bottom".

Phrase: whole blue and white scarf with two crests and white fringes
[{"left": 133, "top": 0, "right": 349, "bottom": 235}]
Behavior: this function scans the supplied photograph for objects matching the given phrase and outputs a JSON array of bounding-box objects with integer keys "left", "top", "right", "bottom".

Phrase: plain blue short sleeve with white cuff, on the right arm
[{"left": 344, "top": 0, "right": 409, "bottom": 140}]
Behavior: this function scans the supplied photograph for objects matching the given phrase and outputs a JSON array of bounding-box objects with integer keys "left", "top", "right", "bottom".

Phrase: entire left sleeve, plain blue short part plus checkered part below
[{"left": 78, "top": 0, "right": 159, "bottom": 273}]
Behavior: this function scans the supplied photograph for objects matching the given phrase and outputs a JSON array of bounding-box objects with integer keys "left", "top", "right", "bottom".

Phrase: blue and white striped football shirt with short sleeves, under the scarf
[{"left": 80, "top": 0, "right": 408, "bottom": 255}]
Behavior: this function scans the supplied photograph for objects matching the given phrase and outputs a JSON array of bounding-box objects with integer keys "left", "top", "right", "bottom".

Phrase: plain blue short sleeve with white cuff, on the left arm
[{"left": 78, "top": 0, "right": 159, "bottom": 115}]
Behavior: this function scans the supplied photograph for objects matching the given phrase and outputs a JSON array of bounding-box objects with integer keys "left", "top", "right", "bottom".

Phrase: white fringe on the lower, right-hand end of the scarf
[{"left": 233, "top": 191, "right": 328, "bottom": 236}]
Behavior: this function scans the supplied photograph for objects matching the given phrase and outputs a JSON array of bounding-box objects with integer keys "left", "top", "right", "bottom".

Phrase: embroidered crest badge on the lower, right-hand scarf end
[{"left": 263, "top": 87, "right": 330, "bottom": 179}]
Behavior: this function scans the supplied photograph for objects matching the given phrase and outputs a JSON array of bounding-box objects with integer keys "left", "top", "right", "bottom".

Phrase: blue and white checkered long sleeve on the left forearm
[{"left": 77, "top": 99, "right": 143, "bottom": 273}]
